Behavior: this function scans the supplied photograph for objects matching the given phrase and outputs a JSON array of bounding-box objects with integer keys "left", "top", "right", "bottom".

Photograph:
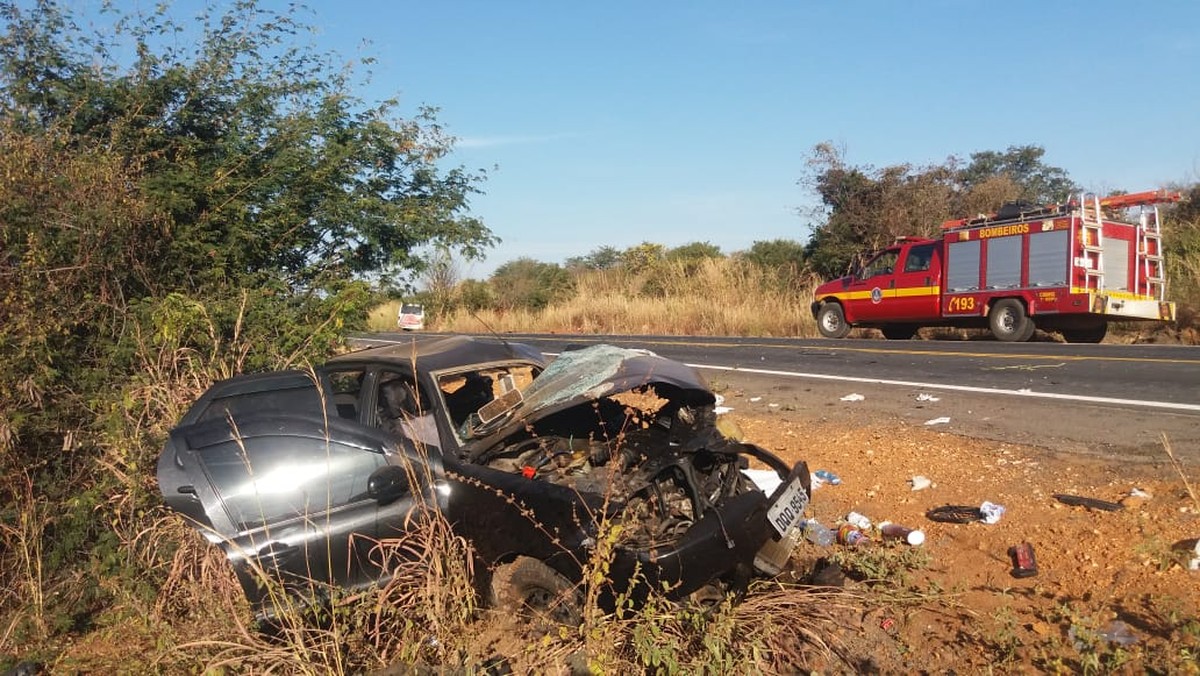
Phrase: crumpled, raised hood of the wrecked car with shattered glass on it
[{"left": 468, "top": 345, "right": 716, "bottom": 448}]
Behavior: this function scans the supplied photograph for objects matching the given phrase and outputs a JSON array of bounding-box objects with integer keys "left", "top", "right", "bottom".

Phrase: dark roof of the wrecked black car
[{"left": 325, "top": 334, "right": 546, "bottom": 371}]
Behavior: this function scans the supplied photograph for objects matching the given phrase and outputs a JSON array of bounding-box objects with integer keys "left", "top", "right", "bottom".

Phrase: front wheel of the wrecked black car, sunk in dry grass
[{"left": 492, "top": 556, "right": 581, "bottom": 626}]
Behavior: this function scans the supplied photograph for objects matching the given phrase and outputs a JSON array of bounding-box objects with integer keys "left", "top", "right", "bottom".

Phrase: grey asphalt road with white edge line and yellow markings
[{"left": 357, "top": 334, "right": 1200, "bottom": 462}]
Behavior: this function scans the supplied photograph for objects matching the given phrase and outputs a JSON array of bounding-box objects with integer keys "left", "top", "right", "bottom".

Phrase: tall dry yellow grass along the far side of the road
[{"left": 434, "top": 258, "right": 817, "bottom": 336}]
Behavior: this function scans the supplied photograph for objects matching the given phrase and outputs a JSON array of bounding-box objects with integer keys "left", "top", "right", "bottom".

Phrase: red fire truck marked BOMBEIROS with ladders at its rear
[{"left": 812, "top": 190, "right": 1181, "bottom": 342}]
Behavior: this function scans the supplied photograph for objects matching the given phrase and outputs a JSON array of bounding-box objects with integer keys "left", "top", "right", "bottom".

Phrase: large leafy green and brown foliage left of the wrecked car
[{"left": 0, "top": 0, "right": 493, "bottom": 638}]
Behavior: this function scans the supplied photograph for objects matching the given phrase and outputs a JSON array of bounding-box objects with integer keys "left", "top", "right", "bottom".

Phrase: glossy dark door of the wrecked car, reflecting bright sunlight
[{"left": 163, "top": 417, "right": 413, "bottom": 608}]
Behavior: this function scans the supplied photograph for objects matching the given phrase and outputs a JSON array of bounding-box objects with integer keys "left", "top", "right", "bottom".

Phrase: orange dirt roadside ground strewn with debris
[{"left": 714, "top": 384, "right": 1200, "bottom": 674}]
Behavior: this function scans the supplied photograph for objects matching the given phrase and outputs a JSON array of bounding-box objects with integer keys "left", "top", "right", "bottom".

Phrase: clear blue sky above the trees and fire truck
[{"left": 82, "top": 0, "right": 1200, "bottom": 277}]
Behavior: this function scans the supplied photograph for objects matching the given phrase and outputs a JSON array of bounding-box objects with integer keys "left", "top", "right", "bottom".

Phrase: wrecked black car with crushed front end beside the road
[{"left": 158, "top": 336, "right": 810, "bottom": 615}]
